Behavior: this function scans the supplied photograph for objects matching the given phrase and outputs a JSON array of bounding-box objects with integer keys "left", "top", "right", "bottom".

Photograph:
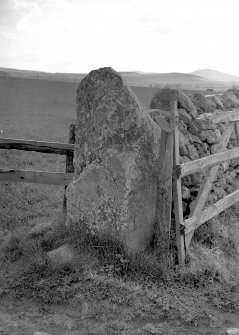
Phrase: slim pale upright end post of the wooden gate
[{"left": 171, "top": 101, "right": 185, "bottom": 267}]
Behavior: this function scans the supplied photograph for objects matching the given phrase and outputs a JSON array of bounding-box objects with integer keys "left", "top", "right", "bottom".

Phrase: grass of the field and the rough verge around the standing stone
[{"left": 0, "top": 79, "right": 239, "bottom": 327}]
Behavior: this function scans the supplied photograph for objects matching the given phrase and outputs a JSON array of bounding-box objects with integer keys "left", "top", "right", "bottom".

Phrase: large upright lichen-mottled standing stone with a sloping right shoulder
[{"left": 66, "top": 68, "right": 160, "bottom": 253}]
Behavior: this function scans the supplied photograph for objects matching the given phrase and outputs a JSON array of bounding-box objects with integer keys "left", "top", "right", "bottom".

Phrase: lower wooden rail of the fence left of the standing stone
[{"left": 0, "top": 170, "right": 74, "bottom": 185}]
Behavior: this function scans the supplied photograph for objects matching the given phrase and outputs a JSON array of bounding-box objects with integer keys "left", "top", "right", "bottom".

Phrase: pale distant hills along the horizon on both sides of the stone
[{"left": 0, "top": 68, "right": 239, "bottom": 90}]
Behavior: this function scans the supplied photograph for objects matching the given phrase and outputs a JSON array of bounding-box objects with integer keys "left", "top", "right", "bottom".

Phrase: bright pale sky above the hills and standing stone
[{"left": 0, "top": 0, "right": 239, "bottom": 76}]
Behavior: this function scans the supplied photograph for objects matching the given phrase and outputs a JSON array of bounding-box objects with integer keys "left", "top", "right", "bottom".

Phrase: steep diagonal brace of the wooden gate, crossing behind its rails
[{"left": 185, "top": 123, "right": 234, "bottom": 249}]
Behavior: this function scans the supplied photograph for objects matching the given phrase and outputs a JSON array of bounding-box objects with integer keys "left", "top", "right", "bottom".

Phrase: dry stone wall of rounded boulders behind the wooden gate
[{"left": 150, "top": 88, "right": 239, "bottom": 216}]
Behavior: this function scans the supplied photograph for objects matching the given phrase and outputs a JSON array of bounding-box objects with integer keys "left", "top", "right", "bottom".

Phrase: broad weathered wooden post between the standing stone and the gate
[{"left": 155, "top": 101, "right": 173, "bottom": 265}]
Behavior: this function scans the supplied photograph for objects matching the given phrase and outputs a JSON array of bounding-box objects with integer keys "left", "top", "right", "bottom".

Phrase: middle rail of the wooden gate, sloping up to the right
[{"left": 176, "top": 147, "right": 239, "bottom": 178}]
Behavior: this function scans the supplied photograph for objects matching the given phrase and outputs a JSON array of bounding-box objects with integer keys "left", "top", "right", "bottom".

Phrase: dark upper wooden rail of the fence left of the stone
[{"left": 0, "top": 138, "right": 74, "bottom": 155}]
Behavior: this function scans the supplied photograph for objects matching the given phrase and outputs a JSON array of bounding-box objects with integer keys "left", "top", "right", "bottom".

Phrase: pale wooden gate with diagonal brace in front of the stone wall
[{"left": 161, "top": 102, "right": 239, "bottom": 266}]
